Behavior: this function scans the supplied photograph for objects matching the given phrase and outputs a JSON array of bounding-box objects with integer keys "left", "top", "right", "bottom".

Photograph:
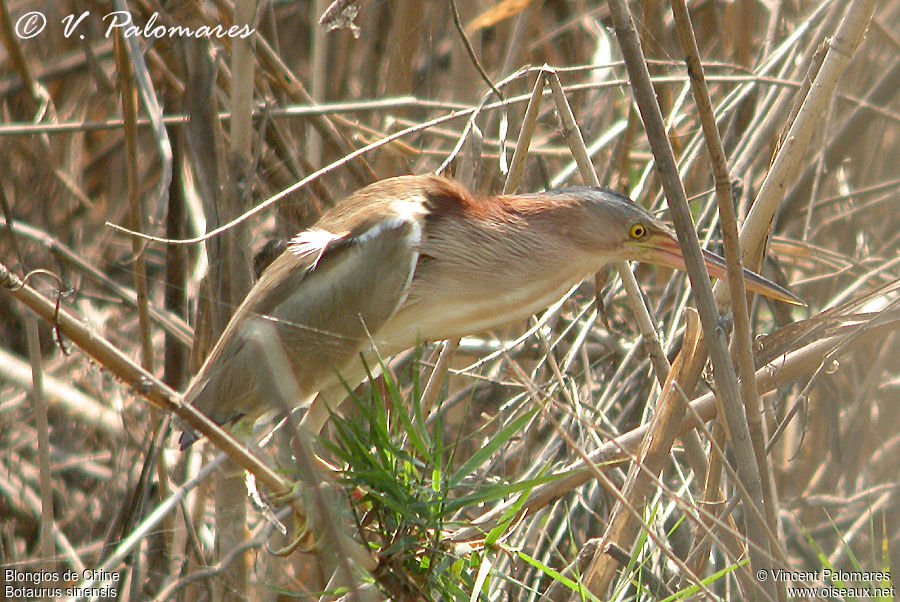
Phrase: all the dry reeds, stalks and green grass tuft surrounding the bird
[{"left": 0, "top": 0, "right": 900, "bottom": 600}]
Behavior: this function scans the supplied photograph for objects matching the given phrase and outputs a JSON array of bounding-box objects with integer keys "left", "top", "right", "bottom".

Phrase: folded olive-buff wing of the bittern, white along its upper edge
[{"left": 185, "top": 217, "right": 422, "bottom": 436}]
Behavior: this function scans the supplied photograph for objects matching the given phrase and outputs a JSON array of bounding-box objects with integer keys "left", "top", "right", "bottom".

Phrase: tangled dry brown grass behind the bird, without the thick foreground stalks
[{"left": 0, "top": 0, "right": 900, "bottom": 600}]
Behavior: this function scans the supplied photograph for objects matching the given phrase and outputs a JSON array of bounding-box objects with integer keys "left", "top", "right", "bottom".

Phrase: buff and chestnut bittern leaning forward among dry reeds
[{"left": 180, "top": 174, "right": 802, "bottom": 449}]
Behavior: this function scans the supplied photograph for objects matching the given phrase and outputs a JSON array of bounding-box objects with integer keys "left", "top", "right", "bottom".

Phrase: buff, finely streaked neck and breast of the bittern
[{"left": 376, "top": 213, "right": 597, "bottom": 353}]
